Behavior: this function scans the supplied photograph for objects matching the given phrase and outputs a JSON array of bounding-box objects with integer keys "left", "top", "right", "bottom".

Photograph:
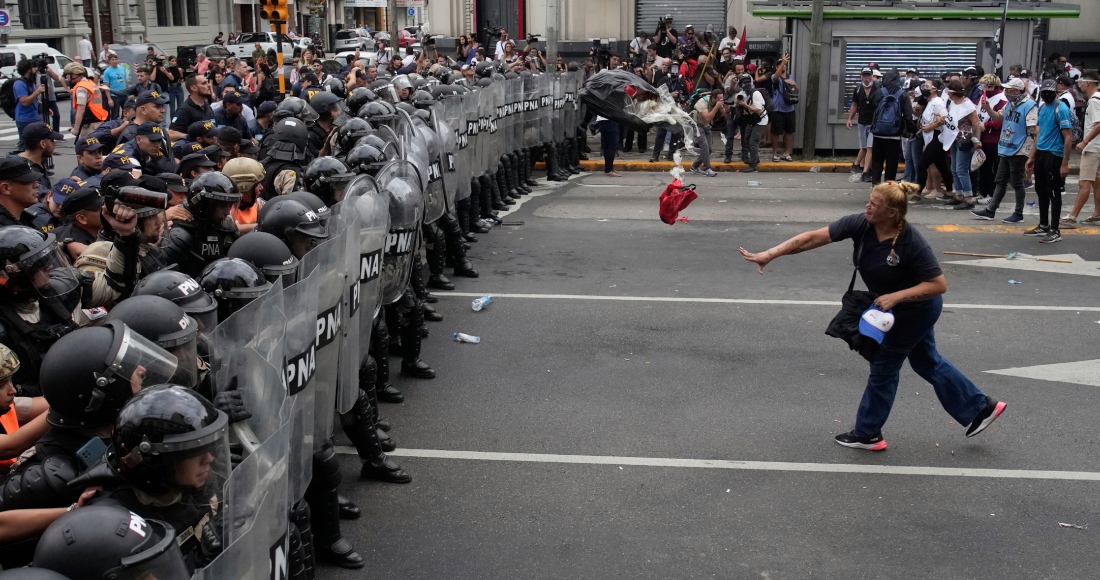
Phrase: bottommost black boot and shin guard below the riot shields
[{"left": 306, "top": 444, "right": 366, "bottom": 569}]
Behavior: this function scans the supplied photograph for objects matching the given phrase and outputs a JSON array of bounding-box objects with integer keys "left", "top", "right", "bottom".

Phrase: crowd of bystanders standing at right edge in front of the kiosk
[{"left": 848, "top": 57, "right": 1100, "bottom": 243}]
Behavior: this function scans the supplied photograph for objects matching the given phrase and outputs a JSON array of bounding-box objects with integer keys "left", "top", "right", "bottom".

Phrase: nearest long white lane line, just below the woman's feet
[{"left": 337, "top": 446, "right": 1100, "bottom": 481}]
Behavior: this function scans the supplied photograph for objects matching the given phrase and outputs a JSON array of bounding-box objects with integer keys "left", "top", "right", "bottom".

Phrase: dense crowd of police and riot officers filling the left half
[{"left": 0, "top": 35, "right": 583, "bottom": 580}]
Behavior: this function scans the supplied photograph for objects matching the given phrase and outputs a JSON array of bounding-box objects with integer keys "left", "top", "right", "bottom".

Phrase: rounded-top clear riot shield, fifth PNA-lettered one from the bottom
[{"left": 374, "top": 161, "right": 424, "bottom": 305}]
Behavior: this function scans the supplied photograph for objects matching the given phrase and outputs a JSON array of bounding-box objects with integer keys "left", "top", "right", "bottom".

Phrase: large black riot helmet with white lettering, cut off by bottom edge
[{"left": 31, "top": 503, "right": 191, "bottom": 580}]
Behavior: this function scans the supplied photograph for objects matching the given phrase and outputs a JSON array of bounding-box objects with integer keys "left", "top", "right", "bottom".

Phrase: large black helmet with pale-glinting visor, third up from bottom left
[{"left": 39, "top": 320, "right": 178, "bottom": 427}]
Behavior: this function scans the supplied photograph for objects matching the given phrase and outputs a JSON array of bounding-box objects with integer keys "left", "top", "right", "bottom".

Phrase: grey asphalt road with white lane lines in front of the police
[{"left": 322, "top": 168, "right": 1100, "bottom": 579}]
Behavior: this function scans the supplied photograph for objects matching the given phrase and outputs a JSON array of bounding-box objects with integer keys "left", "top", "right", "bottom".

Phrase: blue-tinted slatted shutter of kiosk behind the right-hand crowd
[{"left": 840, "top": 41, "right": 978, "bottom": 110}]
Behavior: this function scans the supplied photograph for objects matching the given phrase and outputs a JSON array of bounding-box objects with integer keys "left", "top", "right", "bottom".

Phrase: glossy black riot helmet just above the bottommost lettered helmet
[{"left": 107, "top": 384, "right": 229, "bottom": 496}]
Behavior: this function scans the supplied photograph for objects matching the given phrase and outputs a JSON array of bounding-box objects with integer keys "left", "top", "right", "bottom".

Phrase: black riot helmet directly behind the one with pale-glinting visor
[{"left": 103, "top": 296, "right": 199, "bottom": 389}]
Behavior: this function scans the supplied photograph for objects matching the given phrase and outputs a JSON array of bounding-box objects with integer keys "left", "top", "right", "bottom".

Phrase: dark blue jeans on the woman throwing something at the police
[{"left": 855, "top": 296, "right": 986, "bottom": 437}]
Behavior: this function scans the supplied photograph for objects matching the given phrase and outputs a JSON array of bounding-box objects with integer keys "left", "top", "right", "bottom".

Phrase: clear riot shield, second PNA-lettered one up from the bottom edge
[{"left": 283, "top": 269, "right": 323, "bottom": 503}]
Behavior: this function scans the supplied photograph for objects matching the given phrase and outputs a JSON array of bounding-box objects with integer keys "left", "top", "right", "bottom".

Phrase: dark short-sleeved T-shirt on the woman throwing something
[{"left": 828, "top": 214, "right": 944, "bottom": 308}]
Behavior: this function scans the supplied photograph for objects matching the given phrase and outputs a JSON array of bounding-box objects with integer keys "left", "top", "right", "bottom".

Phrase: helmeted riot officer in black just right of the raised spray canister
[{"left": 162, "top": 172, "right": 241, "bottom": 276}]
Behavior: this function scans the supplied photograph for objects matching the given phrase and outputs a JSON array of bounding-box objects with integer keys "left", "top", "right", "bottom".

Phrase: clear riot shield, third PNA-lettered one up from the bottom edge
[{"left": 301, "top": 220, "right": 348, "bottom": 451}]
